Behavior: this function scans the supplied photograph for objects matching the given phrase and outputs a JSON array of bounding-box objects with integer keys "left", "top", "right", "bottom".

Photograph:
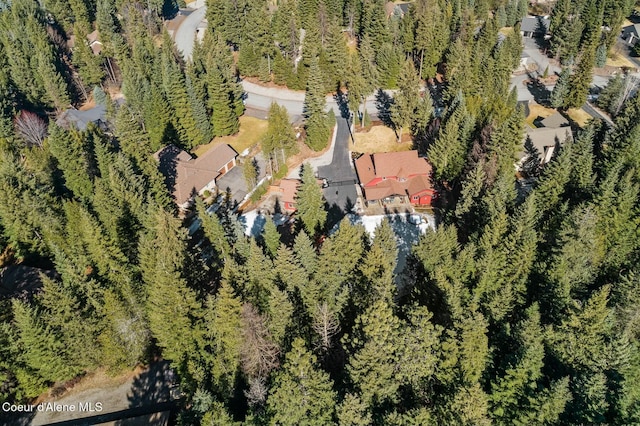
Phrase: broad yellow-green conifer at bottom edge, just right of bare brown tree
[{"left": 268, "top": 339, "right": 336, "bottom": 425}]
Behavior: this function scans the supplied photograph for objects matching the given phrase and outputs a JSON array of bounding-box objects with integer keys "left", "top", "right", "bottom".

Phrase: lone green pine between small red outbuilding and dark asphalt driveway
[{"left": 296, "top": 164, "right": 327, "bottom": 235}]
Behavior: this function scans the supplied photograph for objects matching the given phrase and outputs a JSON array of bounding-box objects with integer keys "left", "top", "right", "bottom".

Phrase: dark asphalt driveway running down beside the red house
[{"left": 318, "top": 117, "right": 358, "bottom": 225}]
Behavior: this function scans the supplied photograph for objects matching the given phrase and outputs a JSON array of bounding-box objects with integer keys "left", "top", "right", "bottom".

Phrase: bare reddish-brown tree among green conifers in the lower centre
[{"left": 240, "top": 304, "right": 280, "bottom": 377}]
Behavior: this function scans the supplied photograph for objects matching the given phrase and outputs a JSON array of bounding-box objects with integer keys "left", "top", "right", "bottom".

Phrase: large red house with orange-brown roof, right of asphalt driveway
[{"left": 355, "top": 150, "right": 435, "bottom": 206}]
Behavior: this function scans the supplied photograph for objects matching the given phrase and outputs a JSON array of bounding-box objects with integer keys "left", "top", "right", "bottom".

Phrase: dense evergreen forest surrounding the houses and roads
[{"left": 0, "top": 0, "right": 640, "bottom": 425}]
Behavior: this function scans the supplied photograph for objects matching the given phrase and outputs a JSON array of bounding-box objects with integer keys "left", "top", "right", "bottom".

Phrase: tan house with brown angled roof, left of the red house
[{"left": 153, "top": 144, "right": 238, "bottom": 210}]
